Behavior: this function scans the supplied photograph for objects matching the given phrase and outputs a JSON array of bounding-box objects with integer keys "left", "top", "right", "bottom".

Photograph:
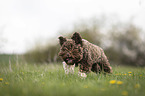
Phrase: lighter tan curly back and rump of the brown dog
[{"left": 82, "top": 39, "right": 111, "bottom": 73}]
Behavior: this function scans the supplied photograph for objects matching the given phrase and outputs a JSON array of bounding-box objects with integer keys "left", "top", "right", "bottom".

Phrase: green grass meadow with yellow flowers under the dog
[{"left": 0, "top": 62, "right": 145, "bottom": 96}]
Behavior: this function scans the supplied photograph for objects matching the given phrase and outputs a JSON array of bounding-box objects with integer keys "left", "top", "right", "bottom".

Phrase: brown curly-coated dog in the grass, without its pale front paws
[{"left": 59, "top": 32, "right": 112, "bottom": 77}]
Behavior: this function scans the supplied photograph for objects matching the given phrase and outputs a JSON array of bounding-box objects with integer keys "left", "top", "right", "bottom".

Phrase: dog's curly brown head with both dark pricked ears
[{"left": 59, "top": 32, "right": 83, "bottom": 65}]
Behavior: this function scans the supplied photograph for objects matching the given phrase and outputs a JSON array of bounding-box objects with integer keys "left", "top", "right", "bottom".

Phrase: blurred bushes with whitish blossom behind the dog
[{"left": 24, "top": 18, "right": 145, "bottom": 66}]
